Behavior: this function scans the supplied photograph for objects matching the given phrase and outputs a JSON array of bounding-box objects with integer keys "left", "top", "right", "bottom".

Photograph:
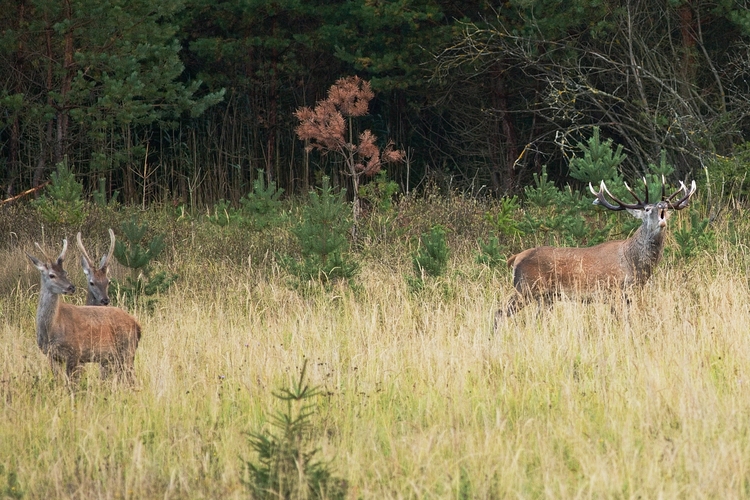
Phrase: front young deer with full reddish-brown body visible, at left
[{"left": 26, "top": 240, "right": 141, "bottom": 380}]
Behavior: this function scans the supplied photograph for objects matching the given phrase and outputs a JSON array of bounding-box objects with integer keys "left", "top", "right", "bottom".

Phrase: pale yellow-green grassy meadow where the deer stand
[{"left": 0, "top": 195, "right": 750, "bottom": 499}]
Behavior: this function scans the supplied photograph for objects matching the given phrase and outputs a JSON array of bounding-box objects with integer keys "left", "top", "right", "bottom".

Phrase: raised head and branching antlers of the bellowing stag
[{"left": 589, "top": 176, "right": 696, "bottom": 235}]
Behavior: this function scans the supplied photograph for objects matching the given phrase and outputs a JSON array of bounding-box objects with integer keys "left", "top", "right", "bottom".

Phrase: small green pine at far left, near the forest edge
[{"left": 34, "top": 157, "right": 86, "bottom": 226}]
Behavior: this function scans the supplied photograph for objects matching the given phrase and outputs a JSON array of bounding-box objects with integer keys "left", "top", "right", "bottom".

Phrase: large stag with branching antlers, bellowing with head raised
[{"left": 495, "top": 178, "right": 696, "bottom": 325}]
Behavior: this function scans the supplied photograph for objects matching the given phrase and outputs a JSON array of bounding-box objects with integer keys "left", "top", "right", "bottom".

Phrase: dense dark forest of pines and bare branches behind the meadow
[{"left": 0, "top": 0, "right": 750, "bottom": 206}]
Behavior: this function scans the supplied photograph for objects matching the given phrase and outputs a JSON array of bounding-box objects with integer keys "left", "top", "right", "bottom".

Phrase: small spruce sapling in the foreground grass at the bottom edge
[{"left": 242, "top": 361, "right": 347, "bottom": 499}]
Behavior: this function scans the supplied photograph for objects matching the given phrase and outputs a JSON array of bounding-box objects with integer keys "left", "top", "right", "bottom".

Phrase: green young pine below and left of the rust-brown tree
[{"left": 280, "top": 177, "right": 359, "bottom": 282}]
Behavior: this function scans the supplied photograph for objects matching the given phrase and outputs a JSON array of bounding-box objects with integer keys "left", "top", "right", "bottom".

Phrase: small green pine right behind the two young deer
[{"left": 110, "top": 217, "right": 177, "bottom": 308}]
